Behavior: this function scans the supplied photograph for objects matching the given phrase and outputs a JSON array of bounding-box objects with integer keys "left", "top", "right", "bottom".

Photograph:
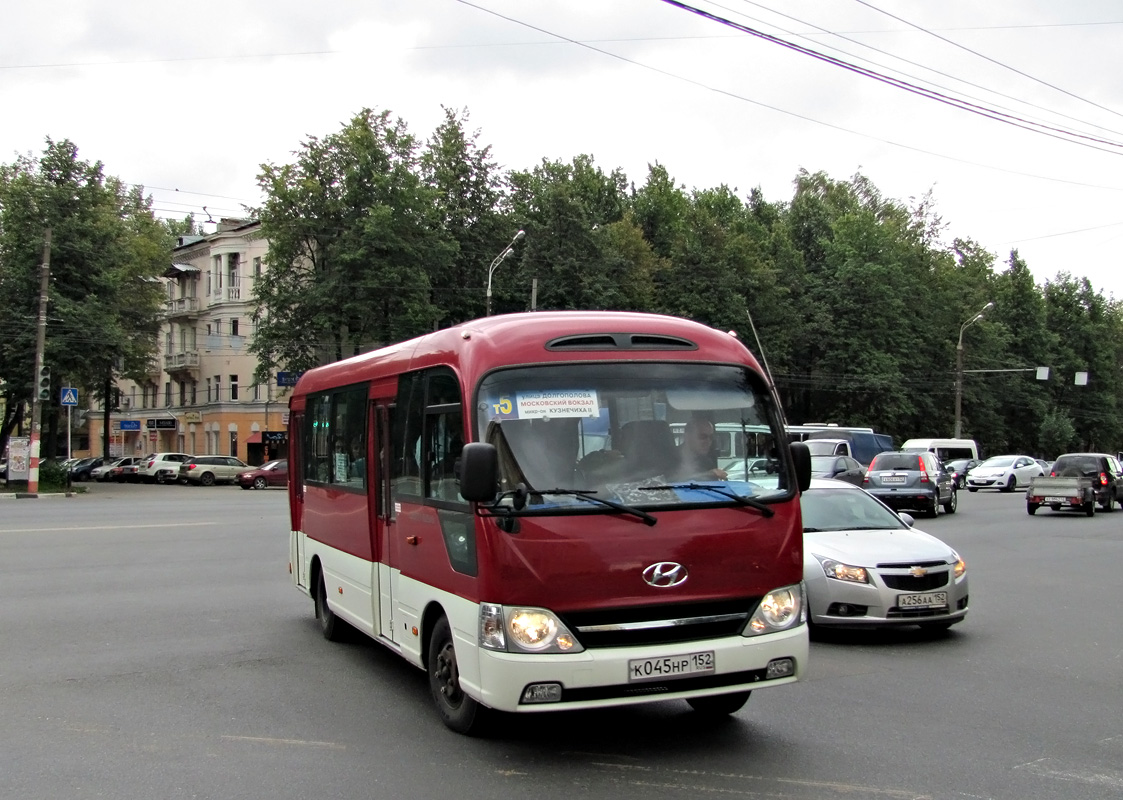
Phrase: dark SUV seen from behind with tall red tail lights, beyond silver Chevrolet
[{"left": 861, "top": 451, "right": 959, "bottom": 517}]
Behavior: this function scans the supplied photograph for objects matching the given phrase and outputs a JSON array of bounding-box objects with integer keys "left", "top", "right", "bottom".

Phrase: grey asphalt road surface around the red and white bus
[{"left": 0, "top": 485, "right": 1123, "bottom": 800}]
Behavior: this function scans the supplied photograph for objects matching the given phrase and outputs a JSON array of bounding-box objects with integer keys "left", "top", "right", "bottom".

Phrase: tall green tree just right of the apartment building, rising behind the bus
[{"left": 250, "top": 109, "right": 456, "bottom": 381}]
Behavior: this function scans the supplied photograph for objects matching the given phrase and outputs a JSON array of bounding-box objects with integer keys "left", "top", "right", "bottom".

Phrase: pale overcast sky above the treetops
[{"left": 0, "top": 0, "right": 1123, "bottom": 299}]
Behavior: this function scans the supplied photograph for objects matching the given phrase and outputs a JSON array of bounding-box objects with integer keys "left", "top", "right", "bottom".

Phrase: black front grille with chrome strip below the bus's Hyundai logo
[{"left": 560, "top": 598, "right": 760, "bottom": 649}]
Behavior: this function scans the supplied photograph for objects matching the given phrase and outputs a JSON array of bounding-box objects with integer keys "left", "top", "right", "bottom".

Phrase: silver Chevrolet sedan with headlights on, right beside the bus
[{"left": 800, "top": 479, "right": 968, "bottom": 629}]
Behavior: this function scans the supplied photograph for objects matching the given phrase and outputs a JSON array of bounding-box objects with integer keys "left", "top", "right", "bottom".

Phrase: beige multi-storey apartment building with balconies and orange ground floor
[{"left": 89, "top": 219, "right": 290, "bottom": 464}]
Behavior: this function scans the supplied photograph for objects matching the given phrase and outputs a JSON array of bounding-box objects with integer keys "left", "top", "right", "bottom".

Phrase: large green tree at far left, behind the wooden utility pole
[{"left": 0, "top": 139, "right": 170, "bottom": 454}]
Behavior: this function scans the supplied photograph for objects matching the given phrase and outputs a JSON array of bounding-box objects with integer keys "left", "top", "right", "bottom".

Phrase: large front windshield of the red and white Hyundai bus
[{"left": 475, "top": 361, "right": 789, "bottom": 512}]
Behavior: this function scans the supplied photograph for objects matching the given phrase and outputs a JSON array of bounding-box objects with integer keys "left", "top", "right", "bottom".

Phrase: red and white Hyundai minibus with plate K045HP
[{"left": 289, "top": 311, "right": 810, "bottom": 733}]
